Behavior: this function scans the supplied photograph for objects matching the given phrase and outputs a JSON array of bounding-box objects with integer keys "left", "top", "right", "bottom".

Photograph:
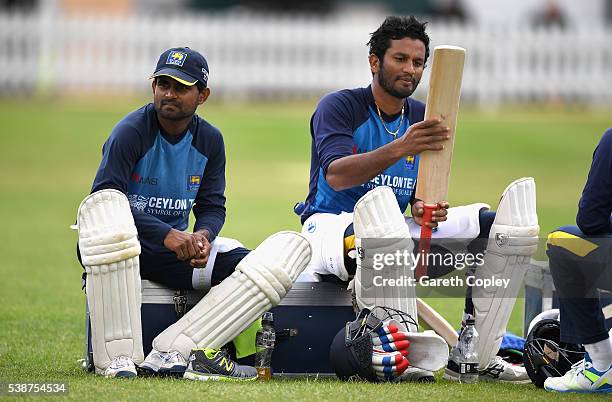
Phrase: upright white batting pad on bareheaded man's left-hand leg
[{"left": 353, "top": 186, "right": 417, "bottom": 331}]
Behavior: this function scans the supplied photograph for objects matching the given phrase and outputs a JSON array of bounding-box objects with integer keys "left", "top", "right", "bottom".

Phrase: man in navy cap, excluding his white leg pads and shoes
[{"left": 80, "top": 47, "right": 248, "bottom": 289}]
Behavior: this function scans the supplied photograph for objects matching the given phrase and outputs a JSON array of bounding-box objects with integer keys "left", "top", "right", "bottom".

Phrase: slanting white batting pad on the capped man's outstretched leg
[{"left": 153, "top": 231, "right": 312, "bottom": 359}]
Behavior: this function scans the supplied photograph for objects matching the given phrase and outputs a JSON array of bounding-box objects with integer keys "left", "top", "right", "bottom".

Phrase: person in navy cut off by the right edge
[{"left": 544, "top": 129, "right": 612, "bottom": 393}]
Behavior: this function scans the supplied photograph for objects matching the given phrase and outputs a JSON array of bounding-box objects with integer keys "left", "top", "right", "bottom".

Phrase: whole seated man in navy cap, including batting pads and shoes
[{"left": 77, "top": 47, "right": 310, "bottom": 380}]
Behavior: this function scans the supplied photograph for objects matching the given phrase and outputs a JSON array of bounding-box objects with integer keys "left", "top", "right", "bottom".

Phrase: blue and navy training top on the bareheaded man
[{"left": 301, "top": 86, "right": 425, "bottom": 223}]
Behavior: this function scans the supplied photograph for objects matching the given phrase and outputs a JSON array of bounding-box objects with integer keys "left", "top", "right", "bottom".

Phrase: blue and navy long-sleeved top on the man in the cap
[{"left": 91, "top": 103, "right": 225, "bottom": 250}]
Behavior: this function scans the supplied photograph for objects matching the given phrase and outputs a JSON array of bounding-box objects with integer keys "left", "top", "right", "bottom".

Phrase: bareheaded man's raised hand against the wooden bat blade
[{"left": 396, "top": 118, "right": 450, "bottom": 155}]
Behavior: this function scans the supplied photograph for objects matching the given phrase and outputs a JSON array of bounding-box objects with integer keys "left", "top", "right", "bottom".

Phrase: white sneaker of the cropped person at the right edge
[{"left": 544, "top": 353, "right": 612, "bottom": 393}]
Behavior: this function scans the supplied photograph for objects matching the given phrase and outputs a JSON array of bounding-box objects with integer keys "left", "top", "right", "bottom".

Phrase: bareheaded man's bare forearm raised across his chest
[{"left": 325, "top": 142, "right": 403, "bottom": 191}]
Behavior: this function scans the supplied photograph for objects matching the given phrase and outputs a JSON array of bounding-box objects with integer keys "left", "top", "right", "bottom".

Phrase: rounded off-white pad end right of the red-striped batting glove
[{"left": 407, "top": 330, "right": 448, "bottom": 371}]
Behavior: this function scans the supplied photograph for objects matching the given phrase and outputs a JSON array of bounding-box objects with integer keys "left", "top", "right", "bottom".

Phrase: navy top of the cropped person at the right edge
[{"left": 576, "top": 128, "right": 612, "bottom": 235}]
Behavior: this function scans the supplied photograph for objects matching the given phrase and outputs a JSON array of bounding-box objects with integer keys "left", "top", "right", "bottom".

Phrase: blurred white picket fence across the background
[{"left": 0, "top": 14, "right": 612, "bottom": 105}]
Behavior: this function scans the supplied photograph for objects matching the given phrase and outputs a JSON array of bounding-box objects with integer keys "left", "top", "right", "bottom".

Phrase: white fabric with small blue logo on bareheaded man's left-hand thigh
[{"left": 302, "top": 212, "right": 353, "bottom": 281}]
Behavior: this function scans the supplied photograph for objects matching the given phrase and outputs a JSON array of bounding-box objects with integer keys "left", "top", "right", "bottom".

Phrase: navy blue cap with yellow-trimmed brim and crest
[{"left": 150, "top": 47, "right": 208, "bottom": 86}]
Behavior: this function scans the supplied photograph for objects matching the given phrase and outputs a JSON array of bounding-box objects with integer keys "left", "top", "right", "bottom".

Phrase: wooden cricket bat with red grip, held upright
[{"left": 415, "top": 45, "right": 465, "bottom": 279}]
